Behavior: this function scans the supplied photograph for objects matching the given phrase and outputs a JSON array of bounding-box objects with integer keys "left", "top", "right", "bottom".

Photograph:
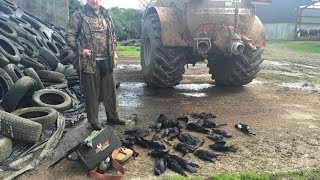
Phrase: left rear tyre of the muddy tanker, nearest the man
[{"left": 141, "top": 14, "right": 186, "bottom": 88}]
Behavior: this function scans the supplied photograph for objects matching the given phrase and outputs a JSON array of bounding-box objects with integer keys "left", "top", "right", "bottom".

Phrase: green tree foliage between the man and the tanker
[{"left": 109, "top": 7, "right": 143, "bottom": 41}]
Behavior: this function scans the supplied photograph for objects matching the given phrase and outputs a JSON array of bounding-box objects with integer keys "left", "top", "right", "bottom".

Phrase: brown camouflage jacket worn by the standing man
[{"left": 67, "top": 4, "right": 116, "bottom": 74}]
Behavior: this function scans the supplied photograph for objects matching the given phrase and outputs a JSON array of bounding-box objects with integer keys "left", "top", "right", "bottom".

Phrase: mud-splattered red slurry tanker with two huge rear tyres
[{"left": 141, "top": 0, "right": 270, "bottom": 87}]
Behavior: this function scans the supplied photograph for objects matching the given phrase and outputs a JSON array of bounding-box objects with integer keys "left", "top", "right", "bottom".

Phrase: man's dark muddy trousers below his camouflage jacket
[{"left": 81, "top": 60, "right": 119, "bottom": 124}]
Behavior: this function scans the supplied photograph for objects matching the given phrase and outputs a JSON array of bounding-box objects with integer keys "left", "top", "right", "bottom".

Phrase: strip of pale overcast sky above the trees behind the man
[{"left": 83, "top": 0, "right": 139, "bottom": 9}]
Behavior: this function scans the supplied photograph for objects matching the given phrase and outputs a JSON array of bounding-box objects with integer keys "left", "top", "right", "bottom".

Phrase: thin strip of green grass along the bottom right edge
[{"left": 164, "top": 169, "right": 320, "bottom": 180}]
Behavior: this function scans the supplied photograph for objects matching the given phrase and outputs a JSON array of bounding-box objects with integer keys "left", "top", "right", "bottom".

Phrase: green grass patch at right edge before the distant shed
[{"left": 280, "top": 41, "right": 320, "bottom": 53}]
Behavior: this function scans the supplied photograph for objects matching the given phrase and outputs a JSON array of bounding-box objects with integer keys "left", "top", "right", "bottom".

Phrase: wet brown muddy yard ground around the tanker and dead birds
[{"left": 2, "top": 43, "right": 320, "bottom": 179}]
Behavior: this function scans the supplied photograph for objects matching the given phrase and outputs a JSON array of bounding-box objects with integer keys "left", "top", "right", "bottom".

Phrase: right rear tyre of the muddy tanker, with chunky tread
[{"left": 208, "top": 45, "right": 263, "bottom": 87}]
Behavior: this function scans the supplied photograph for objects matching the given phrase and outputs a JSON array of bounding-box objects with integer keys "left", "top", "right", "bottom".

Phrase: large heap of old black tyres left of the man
[{"left": 0, "top": 0, "right": 77, "bottom": 162}]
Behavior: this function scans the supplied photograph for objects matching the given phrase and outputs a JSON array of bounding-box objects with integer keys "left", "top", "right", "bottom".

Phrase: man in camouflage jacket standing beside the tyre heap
[{"left": 67, "top": 0, "right": 125, "bottom": 130}]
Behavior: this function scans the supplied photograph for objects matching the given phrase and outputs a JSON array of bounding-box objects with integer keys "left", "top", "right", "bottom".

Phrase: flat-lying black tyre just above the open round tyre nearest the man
[{"left": 37, "top": 70, "right": 67, "bottom": 84}]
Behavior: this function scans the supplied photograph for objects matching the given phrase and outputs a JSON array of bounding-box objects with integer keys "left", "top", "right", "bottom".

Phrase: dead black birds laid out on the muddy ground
[{"left": 121, "top": 113, "right": 253, "bottom": 176}]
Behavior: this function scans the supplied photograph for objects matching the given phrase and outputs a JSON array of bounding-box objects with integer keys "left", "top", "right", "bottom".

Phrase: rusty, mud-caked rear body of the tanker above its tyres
[{"left": 146, "top": 0, "right": 271, "bottom": 55}]
